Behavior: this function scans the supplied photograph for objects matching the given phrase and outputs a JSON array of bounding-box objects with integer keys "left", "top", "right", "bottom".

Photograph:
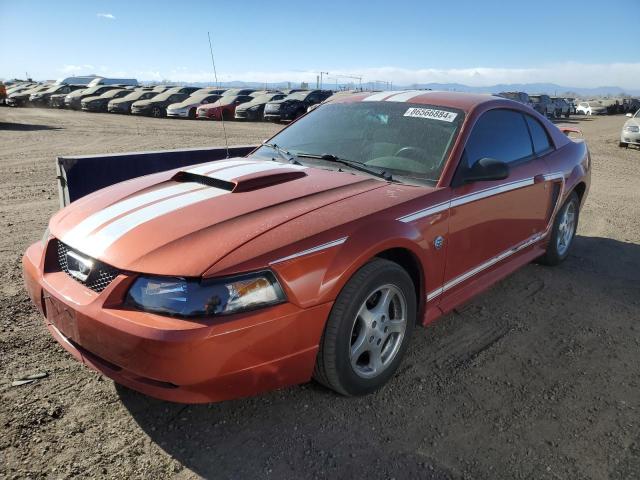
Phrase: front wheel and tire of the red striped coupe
[{"left": 314, "top": 258, "right": 417, "bottom": 396}]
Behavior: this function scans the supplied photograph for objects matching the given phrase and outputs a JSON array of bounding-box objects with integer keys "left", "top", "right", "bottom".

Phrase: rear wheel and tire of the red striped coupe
[{"left": 538, "top": 192, "right": 580, "bottom": 266}]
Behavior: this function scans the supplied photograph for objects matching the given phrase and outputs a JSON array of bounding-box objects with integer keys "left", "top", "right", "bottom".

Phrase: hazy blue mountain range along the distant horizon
[{"left": 149, "top": 81, "right": 640, "bottom": 97}]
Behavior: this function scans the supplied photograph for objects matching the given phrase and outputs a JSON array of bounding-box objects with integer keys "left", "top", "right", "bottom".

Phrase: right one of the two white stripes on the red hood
[{"left": 72, "top": 187, "right": 229, "bottom": 257}]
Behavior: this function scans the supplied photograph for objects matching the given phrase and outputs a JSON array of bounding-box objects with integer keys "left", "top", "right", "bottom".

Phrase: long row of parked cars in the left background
[{"left": 7, "top": 82, "right": 333, "bottom": 122}]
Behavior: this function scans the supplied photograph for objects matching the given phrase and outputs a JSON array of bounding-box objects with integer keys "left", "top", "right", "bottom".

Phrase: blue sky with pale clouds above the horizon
[{"left": 0, "top": 0, "right": 640, "bottom": 89}]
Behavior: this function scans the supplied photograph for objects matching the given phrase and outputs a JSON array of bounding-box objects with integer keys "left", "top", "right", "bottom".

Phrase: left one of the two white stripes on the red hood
[{"left": 61, "top": 183, "right": 202, "bottom": 249}]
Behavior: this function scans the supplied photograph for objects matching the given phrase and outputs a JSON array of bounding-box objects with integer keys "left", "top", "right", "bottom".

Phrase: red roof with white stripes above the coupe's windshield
[{"left": 329, "top": 90, "right": 517, "bottom": 112}]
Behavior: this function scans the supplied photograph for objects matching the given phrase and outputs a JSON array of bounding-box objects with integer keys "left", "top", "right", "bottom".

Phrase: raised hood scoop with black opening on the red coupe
[{"left": 173, "top": 168, "right": 307, "bottom": 193}]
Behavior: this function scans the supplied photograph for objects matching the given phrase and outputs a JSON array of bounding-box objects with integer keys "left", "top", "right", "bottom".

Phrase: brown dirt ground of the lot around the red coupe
[{"left": 0, "top": 108, "right": 640, "bottom": 479}]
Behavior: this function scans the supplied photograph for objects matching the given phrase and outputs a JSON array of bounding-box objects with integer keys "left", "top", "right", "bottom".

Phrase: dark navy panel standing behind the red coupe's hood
[{"left": 56, "top": 145, "right": 257, "bottom": 208}]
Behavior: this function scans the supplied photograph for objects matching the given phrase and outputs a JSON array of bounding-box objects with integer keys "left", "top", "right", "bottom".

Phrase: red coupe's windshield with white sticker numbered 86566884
[{"left": 256, "top": 102, "right": 464, "bottom": 184}]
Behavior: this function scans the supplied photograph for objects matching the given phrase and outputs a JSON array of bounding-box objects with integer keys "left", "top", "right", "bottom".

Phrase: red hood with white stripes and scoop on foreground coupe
[{"left": 49, "top": 158, "right": 387, "bottom": 277}]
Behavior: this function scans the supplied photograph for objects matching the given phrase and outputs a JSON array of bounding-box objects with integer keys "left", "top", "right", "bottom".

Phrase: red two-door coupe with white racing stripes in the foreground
[{"left": 23, "top": 91, "right": 590, "bottom": 403}]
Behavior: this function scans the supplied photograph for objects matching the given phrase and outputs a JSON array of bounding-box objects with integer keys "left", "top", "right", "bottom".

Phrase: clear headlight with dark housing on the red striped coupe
[{"left": 125, "top": 271, "right": 286, "bottom": 317}]
